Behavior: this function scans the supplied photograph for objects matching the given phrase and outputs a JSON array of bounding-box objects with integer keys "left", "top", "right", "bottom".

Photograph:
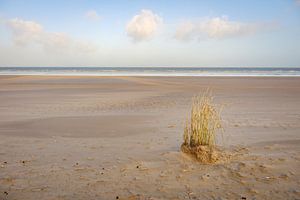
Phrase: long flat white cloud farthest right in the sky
[{"left": 175, "top": 17, "right": 262, "bottom": 40}]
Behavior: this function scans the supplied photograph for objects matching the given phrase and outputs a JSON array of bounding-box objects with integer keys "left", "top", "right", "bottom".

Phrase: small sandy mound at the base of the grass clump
[{"left": 181, "top": 144, "right": 221, "bottom": 164}]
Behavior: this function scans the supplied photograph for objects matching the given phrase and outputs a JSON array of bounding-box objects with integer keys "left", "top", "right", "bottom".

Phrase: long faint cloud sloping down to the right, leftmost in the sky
[{"left": 6, "top": 18, "right": 96, "bottom": 53}]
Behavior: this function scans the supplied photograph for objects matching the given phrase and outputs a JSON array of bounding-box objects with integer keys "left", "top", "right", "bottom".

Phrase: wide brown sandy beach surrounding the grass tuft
[{"left": 0, "top": 76, "right": 300, "bottom": 200}]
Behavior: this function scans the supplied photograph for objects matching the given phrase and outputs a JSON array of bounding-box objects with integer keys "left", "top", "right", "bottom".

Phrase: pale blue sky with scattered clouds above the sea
[{"left": 0, "top": 0, "right": 300, "bottom": 67}]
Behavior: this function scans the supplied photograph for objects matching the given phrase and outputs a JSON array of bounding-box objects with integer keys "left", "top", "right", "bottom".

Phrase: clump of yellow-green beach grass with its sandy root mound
[{"left": 181, "top": 90, "right": 221, "bottom": 163}]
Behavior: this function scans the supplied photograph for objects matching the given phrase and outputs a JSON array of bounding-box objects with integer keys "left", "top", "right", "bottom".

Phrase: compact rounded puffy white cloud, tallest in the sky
[{"left": 126, "top": 10, "right": 162, "bottom": 41}]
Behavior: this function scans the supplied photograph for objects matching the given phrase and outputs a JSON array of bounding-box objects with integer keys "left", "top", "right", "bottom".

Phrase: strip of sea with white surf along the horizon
[{"left": 0, "top": 67, "right": 300, "bottom": 77}]
